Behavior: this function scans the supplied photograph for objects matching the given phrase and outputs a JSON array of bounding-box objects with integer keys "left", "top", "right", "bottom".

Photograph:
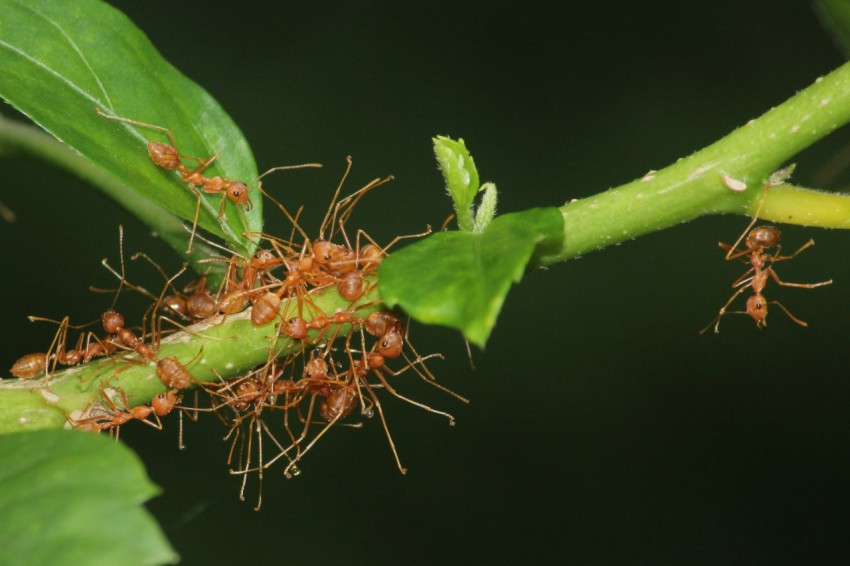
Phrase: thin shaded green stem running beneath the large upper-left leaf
[{"left": 0, "top": 115, "right": 223, "bottom": 283}]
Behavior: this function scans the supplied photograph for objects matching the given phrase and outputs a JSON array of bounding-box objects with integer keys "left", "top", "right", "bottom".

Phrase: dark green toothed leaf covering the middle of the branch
[{"left": 379, "top": 208, "right": 564, "bottom": 347}]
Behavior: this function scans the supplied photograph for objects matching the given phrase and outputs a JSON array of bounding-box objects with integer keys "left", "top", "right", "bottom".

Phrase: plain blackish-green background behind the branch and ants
[{"left": 0, "top": 0, "right": 850, "bottom": 564}]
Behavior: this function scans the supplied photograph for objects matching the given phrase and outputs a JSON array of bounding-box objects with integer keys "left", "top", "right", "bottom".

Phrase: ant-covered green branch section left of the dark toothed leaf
[{"left": 0, "top": 284, "right": 381, "bottom": 434}]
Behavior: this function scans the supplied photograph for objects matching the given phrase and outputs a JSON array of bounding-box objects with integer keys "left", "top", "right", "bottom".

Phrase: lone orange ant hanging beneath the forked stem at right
[{"left": 700, "top": 175, "right": 832, "bottom": 334}]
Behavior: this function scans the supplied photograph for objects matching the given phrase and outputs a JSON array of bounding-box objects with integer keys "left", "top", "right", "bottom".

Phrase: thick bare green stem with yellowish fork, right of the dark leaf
[{"left": 541, "top": 63, "right": 850, "bottom": 265}]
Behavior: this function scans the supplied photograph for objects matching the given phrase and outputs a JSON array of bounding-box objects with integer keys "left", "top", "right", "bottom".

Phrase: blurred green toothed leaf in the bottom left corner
[{"left": 0, "top": 430, "right": 177, "bottom": 565}]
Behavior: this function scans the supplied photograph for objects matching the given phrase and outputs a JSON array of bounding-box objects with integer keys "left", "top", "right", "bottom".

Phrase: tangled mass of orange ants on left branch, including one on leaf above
[{"left": 6, "top": 111, "right": 467, "bottom": 509}]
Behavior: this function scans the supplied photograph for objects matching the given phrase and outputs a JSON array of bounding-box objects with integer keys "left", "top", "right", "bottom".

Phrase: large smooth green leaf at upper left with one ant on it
[{"left": 0, "top": 0, "right": 262, "bottom": 255}]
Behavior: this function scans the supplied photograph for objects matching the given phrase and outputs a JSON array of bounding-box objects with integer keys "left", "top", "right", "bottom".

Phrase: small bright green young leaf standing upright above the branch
[{"left": 434, "top": 136, "right": 479, "bottom": 232}]
